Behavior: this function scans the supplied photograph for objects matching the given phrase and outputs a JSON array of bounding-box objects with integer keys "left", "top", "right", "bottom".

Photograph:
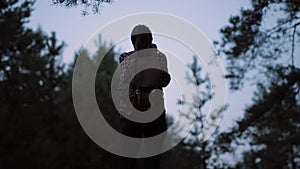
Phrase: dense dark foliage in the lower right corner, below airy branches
[{"left": 222, "top": 70, "right": 300, "bottom": 169}]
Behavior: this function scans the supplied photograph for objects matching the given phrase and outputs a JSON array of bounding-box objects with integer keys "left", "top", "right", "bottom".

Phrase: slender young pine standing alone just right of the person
[{"left": 173, "top": 56, "right": 226, "bottom": 169}]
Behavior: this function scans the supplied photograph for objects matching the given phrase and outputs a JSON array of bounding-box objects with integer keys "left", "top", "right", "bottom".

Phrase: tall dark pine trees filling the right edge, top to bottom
[{"left": 217, "top": 0, "right": 300, "bottom": 169}]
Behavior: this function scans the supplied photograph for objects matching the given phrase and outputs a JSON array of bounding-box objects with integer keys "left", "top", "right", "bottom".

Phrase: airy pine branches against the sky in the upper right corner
[{"left": 219, "top": 0, "right": 300, "bottom": 90}]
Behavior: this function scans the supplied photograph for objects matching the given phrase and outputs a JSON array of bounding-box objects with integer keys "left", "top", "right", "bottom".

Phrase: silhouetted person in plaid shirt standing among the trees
[{"left": 119, "top": 25, "right": 170, "bottom": 169}]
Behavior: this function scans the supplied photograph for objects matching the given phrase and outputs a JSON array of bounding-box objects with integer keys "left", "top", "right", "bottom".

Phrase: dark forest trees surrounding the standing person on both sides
[{"left": 0, "top": 0, "right": 300, "bottom": 169}]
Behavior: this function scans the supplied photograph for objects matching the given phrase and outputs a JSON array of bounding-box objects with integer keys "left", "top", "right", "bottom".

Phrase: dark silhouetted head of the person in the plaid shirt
[{"left": 131, "top": 25, "right": 152, "bottom": 50}]
